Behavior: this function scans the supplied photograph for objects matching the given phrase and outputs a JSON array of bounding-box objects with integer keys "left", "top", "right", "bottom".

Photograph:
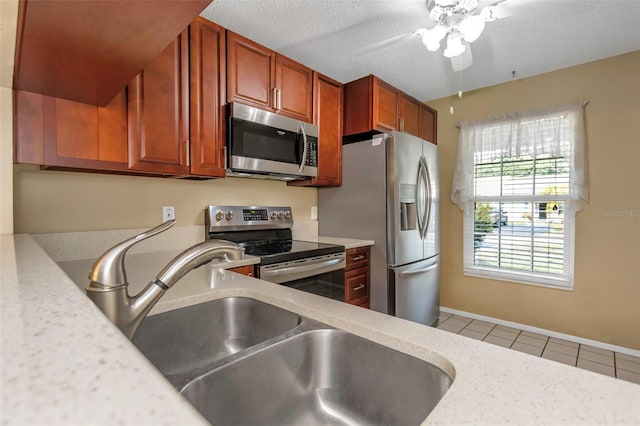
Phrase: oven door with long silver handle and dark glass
[{"left": 259, "top": 253, "right": 345, "bottom": 302}]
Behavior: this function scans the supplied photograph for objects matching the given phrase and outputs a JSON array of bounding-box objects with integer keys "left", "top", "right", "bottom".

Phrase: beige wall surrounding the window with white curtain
[{"left": 428, "top": 51, "right": 640, "bottom": 349}]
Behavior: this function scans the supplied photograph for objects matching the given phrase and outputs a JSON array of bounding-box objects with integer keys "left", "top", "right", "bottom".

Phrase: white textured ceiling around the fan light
[{"left": 202, "top": 0, "right": 640, "bottom": 101}]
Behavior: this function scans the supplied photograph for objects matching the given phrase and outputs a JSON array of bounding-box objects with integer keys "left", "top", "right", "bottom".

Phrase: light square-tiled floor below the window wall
[{"left": 438, "top": 312, "right": 640, "bottom": 384}]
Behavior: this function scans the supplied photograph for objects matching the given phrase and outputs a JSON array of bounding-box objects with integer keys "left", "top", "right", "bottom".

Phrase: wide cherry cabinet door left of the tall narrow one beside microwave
[{"left": 128, "top": 31, "right": 189, "bottom": 175}]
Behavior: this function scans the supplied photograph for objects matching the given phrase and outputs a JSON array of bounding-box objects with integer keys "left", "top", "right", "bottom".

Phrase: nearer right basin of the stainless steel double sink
[{"left": 180, "top": 329, "right": 451, "bottom": 425}]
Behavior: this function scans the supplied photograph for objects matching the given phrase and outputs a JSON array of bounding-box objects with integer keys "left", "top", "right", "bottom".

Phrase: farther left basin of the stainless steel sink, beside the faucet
[{"left": 133, "top": 297, "right": 301, "bottom": 389}]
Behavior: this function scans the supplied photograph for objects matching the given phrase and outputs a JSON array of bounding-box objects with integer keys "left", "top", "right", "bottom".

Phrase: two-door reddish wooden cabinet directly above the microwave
[{"left": 227, "top": 31, "right": 313, "bottom": 122}]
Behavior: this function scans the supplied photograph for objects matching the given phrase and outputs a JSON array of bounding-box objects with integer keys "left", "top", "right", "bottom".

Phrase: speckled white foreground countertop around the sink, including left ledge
[{"left": 0, "top": 235, "right": 640, "bottom": 425}]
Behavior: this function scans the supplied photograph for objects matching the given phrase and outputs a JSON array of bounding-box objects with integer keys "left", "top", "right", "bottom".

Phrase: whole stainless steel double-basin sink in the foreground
[{"left": 133, "top": 297, "right": 451, "bottom": 425}]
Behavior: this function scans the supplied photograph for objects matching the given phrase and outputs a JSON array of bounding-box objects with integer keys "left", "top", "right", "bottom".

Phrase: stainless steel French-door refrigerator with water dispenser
[{"left": 318, "top": 132, "right": 440, "bottom": 325}]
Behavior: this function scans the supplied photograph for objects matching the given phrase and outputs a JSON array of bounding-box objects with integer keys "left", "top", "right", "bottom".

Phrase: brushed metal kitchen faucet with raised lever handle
[{"left": 86, "top": 220, "right": 244, "bottom": 339}]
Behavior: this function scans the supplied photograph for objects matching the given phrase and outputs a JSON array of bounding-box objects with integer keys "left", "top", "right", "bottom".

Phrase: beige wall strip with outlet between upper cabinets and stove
[{"left": 13, "top": 165, "right": 318, "bottom": 235}]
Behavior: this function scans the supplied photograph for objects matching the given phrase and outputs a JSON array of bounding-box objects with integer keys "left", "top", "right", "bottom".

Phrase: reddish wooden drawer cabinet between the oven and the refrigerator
[{"left": 344, "top": 247, "right": 371, "bottom": 308}]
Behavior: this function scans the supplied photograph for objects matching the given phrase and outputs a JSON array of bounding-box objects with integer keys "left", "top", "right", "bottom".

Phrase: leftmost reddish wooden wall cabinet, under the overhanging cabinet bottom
[{"left": 15, "top": 91, "right": 127, "bottom": 172}]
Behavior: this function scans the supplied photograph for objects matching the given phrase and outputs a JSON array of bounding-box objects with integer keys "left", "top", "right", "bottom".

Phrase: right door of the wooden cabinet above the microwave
[{"left": 275, "top": 53, "right": 313, "bottom": 123}]
